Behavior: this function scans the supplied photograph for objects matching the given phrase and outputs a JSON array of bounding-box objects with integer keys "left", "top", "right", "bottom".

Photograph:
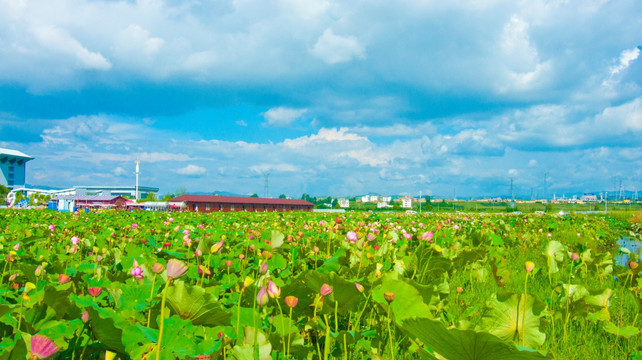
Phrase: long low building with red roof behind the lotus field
[{"left": 170, "top": 195, "right": 314, "bottom": 212}]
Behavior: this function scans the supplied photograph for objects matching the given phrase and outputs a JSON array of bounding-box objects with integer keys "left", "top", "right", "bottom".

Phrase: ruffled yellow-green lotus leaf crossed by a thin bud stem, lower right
[{"left": 483, "top": 293, "right": 546, "bottom": 348}]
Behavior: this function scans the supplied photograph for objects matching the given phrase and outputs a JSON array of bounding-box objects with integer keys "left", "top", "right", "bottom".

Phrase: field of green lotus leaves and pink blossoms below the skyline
[{"left": 0, "top": 210, "right": 642, "bottom": 360}]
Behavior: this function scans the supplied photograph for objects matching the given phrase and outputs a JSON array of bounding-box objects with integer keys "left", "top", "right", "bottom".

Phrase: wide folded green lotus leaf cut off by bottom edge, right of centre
[{"left": 395, "top": 318, "right": 546, "bottom": 360}]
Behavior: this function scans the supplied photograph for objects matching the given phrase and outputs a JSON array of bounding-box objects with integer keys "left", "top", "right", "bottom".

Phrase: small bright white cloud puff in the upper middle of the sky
[{"left": 310, "top": 29, "right": 366, "bottom": 64}]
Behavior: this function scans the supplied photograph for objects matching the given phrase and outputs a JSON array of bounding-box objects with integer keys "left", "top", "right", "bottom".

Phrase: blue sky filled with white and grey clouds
[{"left": 0, "top": 0, "right": 642, "bottom": 197}]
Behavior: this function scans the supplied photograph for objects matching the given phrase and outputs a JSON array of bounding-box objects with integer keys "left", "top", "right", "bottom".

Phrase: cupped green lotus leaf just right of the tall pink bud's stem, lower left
[{"left": 167, "top": 281, "right": 232, "bottom": 326}]
